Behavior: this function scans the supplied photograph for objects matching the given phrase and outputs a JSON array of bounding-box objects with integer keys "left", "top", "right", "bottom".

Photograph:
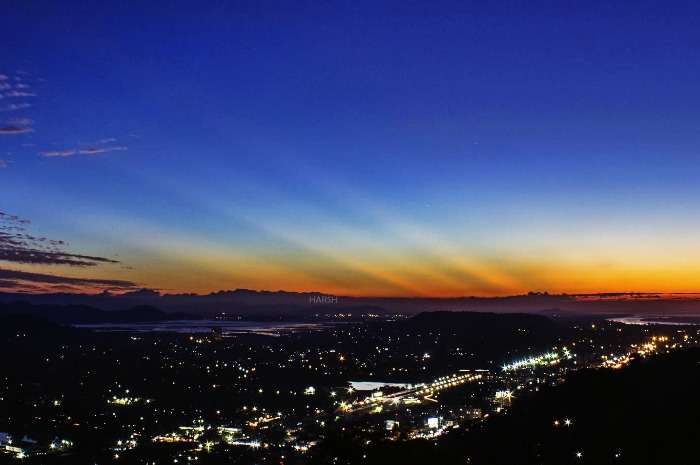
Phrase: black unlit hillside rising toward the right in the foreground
[{"left": 313, "top": 348, "right": 700, "bottom": 465}]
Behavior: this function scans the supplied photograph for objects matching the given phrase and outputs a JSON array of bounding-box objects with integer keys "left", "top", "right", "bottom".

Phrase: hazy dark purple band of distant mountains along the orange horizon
[{"left": 0, "top": 289, "right": 700, "bottom": 316}]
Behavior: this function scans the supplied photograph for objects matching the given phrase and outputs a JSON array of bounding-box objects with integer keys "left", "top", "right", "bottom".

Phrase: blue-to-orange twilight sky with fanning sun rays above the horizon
[{"left": 0, "top": 0, "right": 700, "bottom": 296}]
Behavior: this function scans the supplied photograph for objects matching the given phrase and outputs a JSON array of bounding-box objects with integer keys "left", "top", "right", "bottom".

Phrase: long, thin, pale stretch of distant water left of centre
[{"left": 73, "top": 320, "right": 327, "bottom": 336}]
